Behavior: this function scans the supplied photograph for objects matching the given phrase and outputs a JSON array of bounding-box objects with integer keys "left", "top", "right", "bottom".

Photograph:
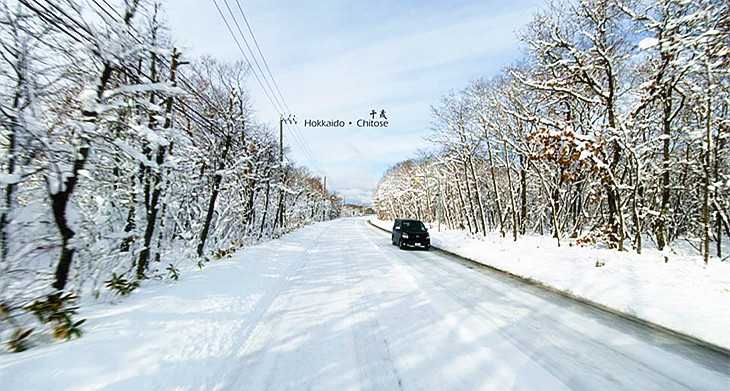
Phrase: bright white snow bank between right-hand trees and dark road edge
[{"left": 370, "top": 218, "right": 730, "bottom": 349}]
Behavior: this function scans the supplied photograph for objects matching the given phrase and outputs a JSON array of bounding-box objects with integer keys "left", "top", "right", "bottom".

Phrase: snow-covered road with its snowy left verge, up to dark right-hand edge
[{"left": 0, "top": 219, "right": 730, "bottom": 391}]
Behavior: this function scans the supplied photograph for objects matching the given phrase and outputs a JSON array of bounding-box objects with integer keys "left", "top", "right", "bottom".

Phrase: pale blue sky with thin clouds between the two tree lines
[{"left": 167, "top": 0, "right": 542, "bottom": 203}]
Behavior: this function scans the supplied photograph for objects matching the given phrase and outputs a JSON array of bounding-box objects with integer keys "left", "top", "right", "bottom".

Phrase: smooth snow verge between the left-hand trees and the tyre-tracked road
[{"left": 0, "top": 226, "right": 322, "bottom": 391}]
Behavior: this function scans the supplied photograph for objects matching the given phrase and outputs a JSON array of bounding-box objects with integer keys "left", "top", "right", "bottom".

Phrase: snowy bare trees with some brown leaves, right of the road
[{"left": 374, "top": 0, "right": 730, "bottom": 262}]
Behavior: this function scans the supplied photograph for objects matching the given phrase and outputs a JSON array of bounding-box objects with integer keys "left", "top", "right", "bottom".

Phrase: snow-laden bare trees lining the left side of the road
[{"left": 0, "top": 0, "right": 339, "bottom": 348}]
